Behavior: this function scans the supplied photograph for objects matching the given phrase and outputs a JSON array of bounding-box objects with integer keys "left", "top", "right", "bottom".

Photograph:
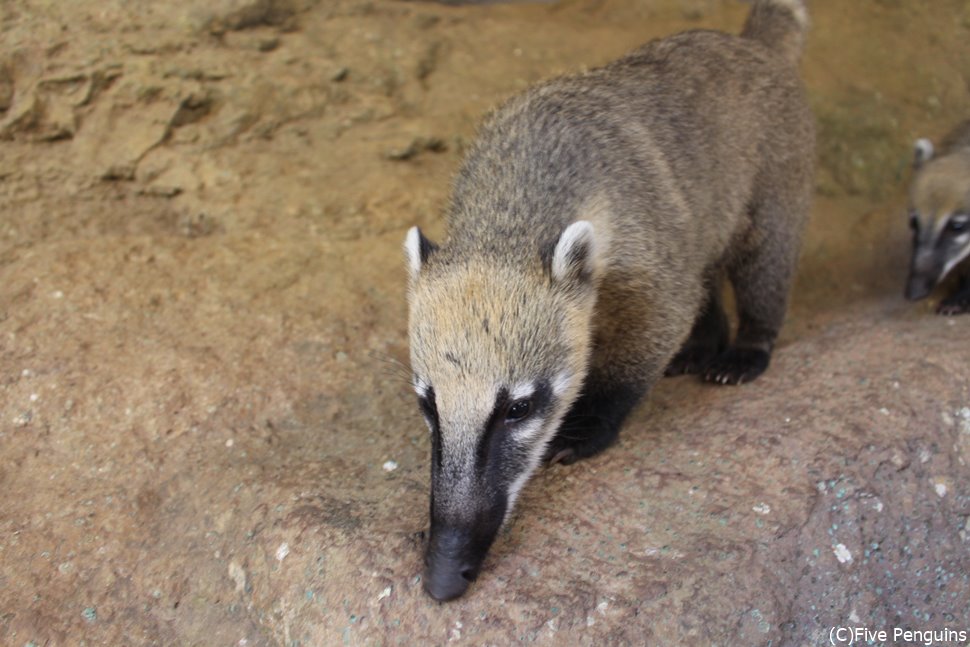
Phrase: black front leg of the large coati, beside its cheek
[{"left": 545, "top": 372, "right": 646, "bottom": 465}]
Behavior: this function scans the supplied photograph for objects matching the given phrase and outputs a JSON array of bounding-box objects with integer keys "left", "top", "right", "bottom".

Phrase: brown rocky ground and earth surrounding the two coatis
[{"left": 0, "top": 0, "right": 970, "bottom": 647}]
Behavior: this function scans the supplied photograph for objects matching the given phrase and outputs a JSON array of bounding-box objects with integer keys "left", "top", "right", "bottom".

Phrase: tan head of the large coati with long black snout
[{"left": 405, "top": 221, "right": 599, "bottom": 600}]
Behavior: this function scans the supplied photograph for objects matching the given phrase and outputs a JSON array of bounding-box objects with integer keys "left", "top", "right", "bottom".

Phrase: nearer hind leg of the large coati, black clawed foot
[{"left": 704, "top": 195, "right": 802, "bottom": 384}]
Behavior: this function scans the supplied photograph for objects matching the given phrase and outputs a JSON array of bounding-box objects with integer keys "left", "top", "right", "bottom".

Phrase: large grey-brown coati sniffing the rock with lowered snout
[{"left": 404, "top": 0, "right": 815, "bottom": 600}]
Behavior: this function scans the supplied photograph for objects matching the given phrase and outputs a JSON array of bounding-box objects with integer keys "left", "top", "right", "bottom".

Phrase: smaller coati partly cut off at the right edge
[{"left": 905, "top": 120, "right": 970, "bottom": 315}]
